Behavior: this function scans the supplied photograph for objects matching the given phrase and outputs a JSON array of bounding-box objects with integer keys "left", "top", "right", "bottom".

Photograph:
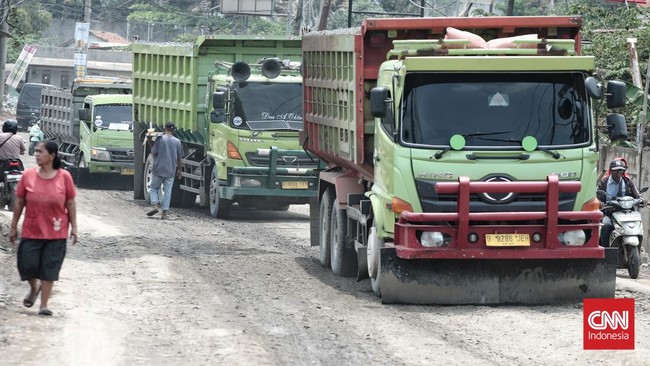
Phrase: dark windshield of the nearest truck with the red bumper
[{"left": 401, "top": 72, "right": 590, "bottom": 149}]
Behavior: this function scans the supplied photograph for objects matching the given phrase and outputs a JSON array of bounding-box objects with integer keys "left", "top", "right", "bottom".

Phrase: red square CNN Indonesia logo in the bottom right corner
[{"left": 583, "top": 299, "right": 634, "bottom": 349}]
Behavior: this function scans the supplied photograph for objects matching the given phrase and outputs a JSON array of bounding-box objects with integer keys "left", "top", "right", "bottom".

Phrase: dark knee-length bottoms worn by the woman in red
[{"left": 17, "top": 239, "right": 66, "bottom": 281}]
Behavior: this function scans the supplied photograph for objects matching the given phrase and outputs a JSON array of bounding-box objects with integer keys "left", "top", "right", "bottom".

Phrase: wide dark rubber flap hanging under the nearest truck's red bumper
[{"left": 379, "top": 248, "right": 617, "bottom": 305}]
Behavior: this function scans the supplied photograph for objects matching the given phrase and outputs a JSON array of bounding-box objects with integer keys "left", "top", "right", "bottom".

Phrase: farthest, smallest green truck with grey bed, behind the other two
[{"left": 41, "top": 78, "right": 134, "bottom": 189}]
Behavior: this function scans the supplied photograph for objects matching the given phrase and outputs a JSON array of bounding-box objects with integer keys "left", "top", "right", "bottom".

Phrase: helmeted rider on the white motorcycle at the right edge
[{"left": 598, "top": 158, "right": 640, "bottom": 247}]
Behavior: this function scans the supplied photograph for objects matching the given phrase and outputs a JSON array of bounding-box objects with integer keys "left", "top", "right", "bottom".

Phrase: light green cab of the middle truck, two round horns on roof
[{"left": 209, "top": 58, "right": 318, "bottom": 213}]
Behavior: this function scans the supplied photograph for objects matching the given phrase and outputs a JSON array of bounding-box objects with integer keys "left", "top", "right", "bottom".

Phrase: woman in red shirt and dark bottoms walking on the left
[{"left": 9, "top": 141, "right": 77, "bottom": 315}]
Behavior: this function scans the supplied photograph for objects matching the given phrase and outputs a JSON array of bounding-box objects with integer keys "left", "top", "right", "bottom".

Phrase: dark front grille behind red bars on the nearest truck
[{"left": 415, "top": 180, "right": 577, "bottom": 212}]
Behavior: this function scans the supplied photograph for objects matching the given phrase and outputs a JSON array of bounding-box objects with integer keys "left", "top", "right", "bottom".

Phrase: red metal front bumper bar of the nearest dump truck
[{"left": 394, "top": 176, "right": 605, "bottom": 259}]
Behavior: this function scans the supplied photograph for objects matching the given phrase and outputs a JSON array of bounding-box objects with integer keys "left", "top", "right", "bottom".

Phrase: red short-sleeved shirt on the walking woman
[{"left": 16, "top": 168, "right": 77, "bottom": 239}]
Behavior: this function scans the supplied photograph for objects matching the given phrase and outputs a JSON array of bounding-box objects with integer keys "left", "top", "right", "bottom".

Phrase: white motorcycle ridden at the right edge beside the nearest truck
[{"left": 598, "top": 187, "right": 648, "bottom": 279}]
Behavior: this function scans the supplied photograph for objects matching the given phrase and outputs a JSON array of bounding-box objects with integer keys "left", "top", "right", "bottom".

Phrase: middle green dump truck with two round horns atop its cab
[{"left": 133, "top": 36, "right": 318, "bottom": 218}]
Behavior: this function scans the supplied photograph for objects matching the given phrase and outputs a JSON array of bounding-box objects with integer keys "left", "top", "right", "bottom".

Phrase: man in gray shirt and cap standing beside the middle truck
[{"left": 147, "top": 121, "right": 185, "bottom": 220}]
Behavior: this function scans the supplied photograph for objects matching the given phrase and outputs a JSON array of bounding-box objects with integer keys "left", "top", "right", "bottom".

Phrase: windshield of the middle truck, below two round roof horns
[{"left": 231, "top": 82, "right": 302, "bottom": 131}]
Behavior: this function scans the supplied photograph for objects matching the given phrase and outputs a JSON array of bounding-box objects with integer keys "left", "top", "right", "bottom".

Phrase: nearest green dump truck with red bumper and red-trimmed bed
[{"left": 303, "top": 17, "right": 625, "bottom": 304}]
